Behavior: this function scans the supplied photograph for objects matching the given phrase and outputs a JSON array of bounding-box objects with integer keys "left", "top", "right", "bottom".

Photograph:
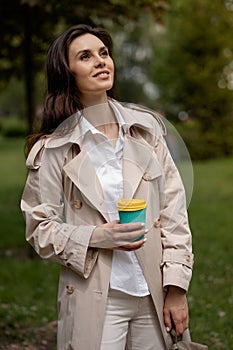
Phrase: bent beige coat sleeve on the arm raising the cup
[{"left": 21, "top": 141, "right": 98, "bottom": 278}]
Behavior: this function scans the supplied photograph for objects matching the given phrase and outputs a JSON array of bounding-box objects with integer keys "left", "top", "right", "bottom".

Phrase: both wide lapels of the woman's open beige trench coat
[{"left": 64, "top": 135, "right": 152, "bottom": 221}]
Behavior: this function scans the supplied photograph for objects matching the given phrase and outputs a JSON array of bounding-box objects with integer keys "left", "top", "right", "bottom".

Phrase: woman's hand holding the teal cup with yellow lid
[{"left": 89, "top": 221, "right": 147, "bottom": 251}]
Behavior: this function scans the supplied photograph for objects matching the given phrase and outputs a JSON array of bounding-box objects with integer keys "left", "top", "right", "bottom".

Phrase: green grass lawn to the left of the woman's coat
[{"left": 0, "top": 138, "right": 58, "bottom": 348}]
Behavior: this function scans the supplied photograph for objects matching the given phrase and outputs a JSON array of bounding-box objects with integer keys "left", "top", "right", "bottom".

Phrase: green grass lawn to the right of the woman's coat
[{"left": 189, "top": 158, "right": 233, "bottom": 350}]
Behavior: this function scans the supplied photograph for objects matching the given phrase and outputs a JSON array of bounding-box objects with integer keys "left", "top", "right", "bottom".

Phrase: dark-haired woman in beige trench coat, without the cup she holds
[{"left": 21, "top": 25, "right": 193, "bottom": 350}]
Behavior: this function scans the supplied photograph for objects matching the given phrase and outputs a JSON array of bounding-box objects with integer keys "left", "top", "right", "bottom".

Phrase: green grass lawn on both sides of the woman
[{"left": 0, "top": 138, "right": 233, "bottom": 350}]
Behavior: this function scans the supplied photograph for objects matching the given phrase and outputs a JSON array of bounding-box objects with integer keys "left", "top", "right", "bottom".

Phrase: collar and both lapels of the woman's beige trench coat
[{"left": 48, "top": 102, "right": 157, "bottom": 221}]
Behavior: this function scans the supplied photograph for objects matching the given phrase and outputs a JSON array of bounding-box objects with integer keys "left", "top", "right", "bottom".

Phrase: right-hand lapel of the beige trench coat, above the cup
[{"left": 123, "top": 135, "right": 153, "bottom": 198}]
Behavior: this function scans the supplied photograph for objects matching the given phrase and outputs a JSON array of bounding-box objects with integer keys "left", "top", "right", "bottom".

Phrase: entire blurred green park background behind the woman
[{"left": 0, "top": 0, "right": 233, "bottom": 350}]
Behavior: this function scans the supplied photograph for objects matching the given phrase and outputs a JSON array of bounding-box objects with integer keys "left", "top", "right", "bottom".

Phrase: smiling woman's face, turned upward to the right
[{"left": 68, "top": 34, "right": 114, "bottom": 100}]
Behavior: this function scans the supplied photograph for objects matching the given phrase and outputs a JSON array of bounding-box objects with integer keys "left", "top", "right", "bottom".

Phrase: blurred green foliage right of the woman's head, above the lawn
[{"left": 110, "top": 0, "right": 233, "bottom": 160}]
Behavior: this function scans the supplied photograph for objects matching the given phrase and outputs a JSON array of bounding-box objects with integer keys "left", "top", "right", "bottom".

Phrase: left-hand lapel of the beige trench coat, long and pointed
[{"left": 64, "top": 150, "right": 109, "bottom": 221}]
